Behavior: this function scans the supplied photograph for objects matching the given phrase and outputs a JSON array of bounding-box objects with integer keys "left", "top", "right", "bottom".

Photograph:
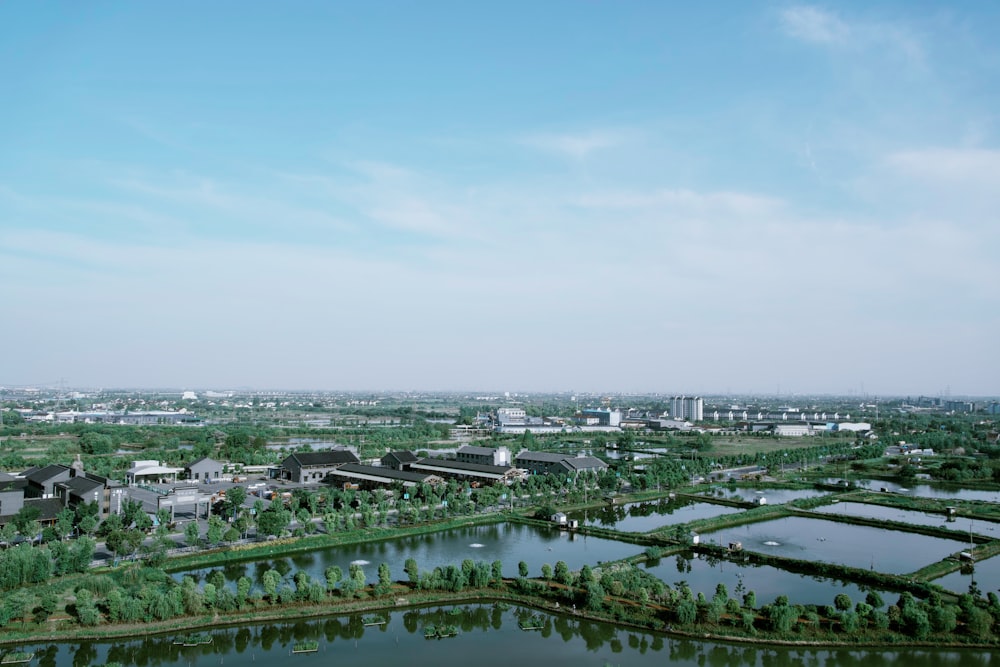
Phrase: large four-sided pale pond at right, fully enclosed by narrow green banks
[{"left": 701, "top": 516, "right": 965, "bottom": 574}]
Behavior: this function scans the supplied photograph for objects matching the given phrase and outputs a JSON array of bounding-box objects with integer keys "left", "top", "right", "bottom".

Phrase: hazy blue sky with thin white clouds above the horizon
[{"left": 0, "top": 1, "right": 1000, "bottom": 395}]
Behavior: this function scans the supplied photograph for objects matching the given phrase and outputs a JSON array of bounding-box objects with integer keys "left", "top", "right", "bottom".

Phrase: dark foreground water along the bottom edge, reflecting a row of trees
[{"left": 13, "top": 605, "right": 991, "bottom": 667}]
